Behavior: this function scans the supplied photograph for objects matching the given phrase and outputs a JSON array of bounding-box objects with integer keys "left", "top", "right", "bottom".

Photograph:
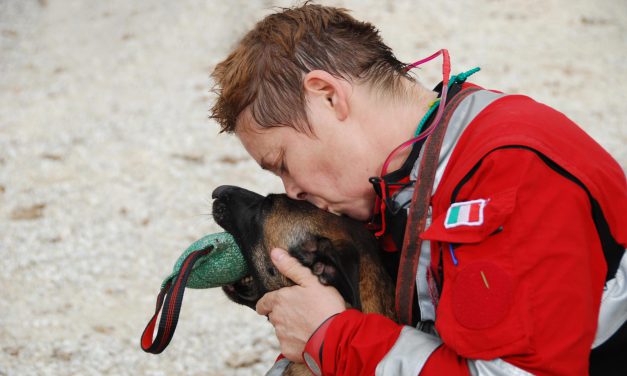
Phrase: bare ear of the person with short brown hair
[{"left": 303, "top": 70, "right": 350, "bottom": 121}]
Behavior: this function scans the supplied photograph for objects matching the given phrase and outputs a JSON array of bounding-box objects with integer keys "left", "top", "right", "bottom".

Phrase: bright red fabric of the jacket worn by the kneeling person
[{"left": 322, "top": 95, "right": 627, "bottom": 376}]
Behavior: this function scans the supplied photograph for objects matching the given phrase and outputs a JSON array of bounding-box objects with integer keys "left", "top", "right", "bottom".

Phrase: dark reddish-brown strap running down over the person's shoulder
[{"left": 396, "top": 88, "right": 479, "bottom": 326}]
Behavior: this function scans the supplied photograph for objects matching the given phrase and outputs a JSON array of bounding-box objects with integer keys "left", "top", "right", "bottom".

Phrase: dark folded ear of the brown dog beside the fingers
[{"left": 289, "top": 237, "right": 361, "bottom": 310}]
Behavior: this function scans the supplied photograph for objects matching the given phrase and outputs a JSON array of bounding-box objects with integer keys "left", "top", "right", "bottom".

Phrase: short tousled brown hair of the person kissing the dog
[{"left": 211, "top": 3, "right": 409, "bottom": 133}]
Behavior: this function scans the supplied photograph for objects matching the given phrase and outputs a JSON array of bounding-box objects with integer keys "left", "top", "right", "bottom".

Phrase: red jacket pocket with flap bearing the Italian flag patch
[{"left": 421, "top": 189, "right": 532, "bottom": 359}]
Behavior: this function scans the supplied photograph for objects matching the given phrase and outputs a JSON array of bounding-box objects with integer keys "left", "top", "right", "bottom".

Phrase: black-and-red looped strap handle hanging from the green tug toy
[{"left": 141, "top": 245, "right": 213, "bottom": 354}]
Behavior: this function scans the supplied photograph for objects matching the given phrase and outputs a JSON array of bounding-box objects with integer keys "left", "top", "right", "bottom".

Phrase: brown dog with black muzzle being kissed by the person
[{"left": 212, "top": 186, "right": 394, "bottom": 375}]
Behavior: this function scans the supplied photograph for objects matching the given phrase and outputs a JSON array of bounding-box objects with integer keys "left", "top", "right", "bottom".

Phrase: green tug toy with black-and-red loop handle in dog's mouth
[{"left": 141, "top": 232, "right": 248, "bottom": 354}]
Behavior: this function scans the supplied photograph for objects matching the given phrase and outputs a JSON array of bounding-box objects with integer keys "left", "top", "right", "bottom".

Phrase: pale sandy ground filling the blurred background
[{"left": 0, "top": 0, "right": 627, "bottom": 375}]
